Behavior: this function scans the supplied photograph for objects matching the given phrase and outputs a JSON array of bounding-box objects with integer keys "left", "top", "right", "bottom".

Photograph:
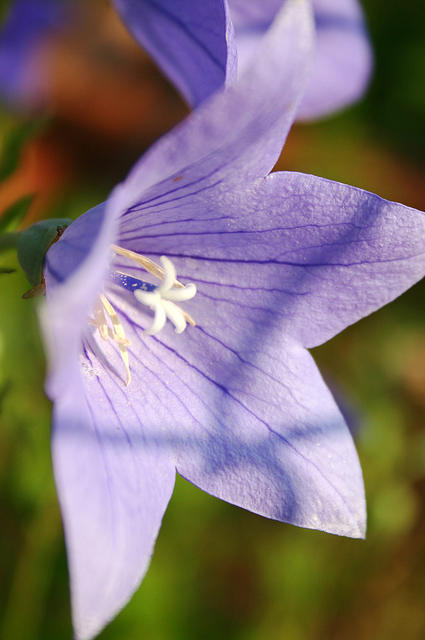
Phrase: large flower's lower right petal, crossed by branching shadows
[{"left": 102, "top": 298, "right": 365, "bottom": 537}]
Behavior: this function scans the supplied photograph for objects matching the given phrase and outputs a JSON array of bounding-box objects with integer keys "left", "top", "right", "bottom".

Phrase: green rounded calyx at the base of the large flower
[{"left": 17, "top": 218, "right": 72, "bottom": 287}]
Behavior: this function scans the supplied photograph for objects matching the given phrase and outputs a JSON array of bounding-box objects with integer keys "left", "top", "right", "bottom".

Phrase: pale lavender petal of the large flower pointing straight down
[{"left": 52, "top": 359, "right": 175, "bottom": 640}]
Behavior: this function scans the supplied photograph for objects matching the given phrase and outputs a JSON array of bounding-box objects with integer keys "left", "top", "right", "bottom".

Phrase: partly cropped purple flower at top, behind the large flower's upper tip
[{"left": 114, "top": 0, "right": 372, "bottom": 115}]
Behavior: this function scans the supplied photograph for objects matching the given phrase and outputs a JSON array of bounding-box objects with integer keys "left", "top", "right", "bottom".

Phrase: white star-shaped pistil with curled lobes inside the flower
[{"left": 134, "top": 256, "right": 196, "bottom": 335}]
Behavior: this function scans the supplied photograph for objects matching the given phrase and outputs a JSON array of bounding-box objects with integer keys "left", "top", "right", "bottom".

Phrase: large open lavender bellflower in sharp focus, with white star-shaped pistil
[{"left": 42, "top": 0, "right": 425, "bottom": 640}]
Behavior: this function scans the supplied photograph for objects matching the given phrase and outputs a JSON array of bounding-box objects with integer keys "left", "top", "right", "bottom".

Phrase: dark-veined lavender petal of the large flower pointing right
[{"left": 119, "top": 172, "right": 425, "bottom": 347}]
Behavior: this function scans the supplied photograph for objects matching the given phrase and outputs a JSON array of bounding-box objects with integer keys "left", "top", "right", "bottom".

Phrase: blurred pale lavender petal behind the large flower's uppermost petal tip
[{"left": 230, "top": 0, "right": 372, "bottom": 120}]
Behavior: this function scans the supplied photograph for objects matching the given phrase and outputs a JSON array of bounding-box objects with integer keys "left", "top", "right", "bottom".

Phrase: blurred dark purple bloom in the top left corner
[{"left": 0, "top": 0, "right": 69, "bottom": 106}]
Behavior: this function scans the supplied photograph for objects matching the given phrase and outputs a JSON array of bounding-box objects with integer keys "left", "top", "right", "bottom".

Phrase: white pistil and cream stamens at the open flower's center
[{"left": 90, "top": 245, "right": 196, "bottom": 386}]
